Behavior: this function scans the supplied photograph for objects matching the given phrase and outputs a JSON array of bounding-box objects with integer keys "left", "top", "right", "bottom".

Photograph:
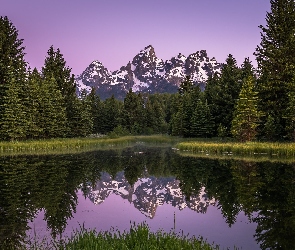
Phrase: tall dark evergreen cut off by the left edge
[{"left": 0, "top": 16, "right": 28, "bottom": 139}]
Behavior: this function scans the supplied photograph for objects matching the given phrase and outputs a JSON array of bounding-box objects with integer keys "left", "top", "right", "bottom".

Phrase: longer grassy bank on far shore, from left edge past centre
[{"left": 0, "top": 135, "right": 180, "bottom": 155}]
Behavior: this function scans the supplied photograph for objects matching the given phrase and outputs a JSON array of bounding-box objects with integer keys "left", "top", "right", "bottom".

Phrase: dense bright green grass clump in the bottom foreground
[{"left": 62, "top": 224, "right": 218, "bottom": 250}]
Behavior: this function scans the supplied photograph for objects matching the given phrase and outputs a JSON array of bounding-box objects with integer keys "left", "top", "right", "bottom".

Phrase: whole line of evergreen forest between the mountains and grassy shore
[{"left": 0, "top": 0, "right": 295, "bottom": 141}]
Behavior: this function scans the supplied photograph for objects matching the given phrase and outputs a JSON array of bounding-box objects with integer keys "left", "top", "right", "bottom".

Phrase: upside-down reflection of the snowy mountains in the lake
[{"left": 87, "top": 172, "right": 215, "bottom": 218}]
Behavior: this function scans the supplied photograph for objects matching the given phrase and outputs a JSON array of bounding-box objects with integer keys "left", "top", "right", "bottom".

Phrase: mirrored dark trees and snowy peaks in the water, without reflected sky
[{"left": 0, "top": 147, "right": 295, "bottom": 249}]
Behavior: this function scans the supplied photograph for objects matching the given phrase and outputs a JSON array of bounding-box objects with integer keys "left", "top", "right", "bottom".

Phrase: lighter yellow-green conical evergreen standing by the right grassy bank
[{"left": 231, "top": 76, "right": 261, "bottom": 141}]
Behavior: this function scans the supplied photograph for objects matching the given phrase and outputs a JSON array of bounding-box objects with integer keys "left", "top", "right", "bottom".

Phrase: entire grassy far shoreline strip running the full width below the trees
[{"left": 0, "top": 135, "right": 295, "bottom": 159}]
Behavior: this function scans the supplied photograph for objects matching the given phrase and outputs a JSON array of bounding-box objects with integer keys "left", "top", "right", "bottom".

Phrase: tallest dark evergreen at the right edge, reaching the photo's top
[{"left": 254, "top": 0, "right": 295, "bottom": 139}]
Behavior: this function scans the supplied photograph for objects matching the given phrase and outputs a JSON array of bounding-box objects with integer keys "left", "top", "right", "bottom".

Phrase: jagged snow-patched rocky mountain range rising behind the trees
[{"left": 76, "top": 45, "right": 223, "bottom": 99}]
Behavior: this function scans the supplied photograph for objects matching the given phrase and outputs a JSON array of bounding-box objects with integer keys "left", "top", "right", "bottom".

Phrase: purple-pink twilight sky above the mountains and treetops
[{"left": 0, "top": 0, "right": 270, "bottom": 74}]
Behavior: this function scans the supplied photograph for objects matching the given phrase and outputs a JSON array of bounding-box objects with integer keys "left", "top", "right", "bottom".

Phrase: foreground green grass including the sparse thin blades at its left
[{"left": 22, "top": 223, "right": 222, "bottom": 250}]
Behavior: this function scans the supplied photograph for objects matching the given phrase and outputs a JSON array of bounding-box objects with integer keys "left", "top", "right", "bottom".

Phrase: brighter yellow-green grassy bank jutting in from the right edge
[{"left": 176, "top": 141, "right": 295, "bottom": 157}]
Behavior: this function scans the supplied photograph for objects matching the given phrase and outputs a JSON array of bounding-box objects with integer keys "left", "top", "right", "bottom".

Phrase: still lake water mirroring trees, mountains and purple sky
[{"left": 0, "top": 146, "right": 295, "bottom": 249}]
